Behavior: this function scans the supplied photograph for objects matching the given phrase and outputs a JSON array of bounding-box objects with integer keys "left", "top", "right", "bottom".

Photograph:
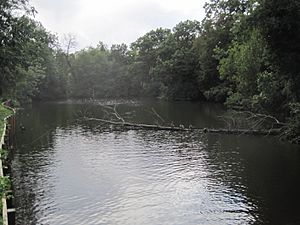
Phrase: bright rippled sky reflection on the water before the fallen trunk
[{"left": 14, "top": 127, "right": 255, "bottom": 225}]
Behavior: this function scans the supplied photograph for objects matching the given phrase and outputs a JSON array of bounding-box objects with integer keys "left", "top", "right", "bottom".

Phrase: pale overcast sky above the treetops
[{"left": 30, "top": 0, "right": 207, "bottom": 48}]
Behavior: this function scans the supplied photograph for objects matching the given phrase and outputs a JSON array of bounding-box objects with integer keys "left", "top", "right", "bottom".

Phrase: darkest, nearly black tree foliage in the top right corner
[{"left": 253, "top": 0, "right": 300, "bottom": 101}]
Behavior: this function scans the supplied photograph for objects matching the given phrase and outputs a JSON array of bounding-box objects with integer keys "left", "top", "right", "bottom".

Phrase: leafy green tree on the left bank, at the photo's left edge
[{"left": 0, "top": 0, "right": 54, "bottom": 100}]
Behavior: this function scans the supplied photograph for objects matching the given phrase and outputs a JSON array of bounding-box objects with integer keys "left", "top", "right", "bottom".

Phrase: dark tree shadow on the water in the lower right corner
[{"left": 207, "top": 135, "right": 300, "bottom": 224}]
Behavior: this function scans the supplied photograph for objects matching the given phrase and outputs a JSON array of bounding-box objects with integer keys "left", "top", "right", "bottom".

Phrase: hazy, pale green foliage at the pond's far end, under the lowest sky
[{"left": 69, "top": 44, "right": 139, "bottom": 98}]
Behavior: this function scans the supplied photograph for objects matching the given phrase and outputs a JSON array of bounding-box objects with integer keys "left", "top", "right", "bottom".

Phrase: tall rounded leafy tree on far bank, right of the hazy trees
[{"left": 151, "top": 20, "right": 201, "bottom": 100}]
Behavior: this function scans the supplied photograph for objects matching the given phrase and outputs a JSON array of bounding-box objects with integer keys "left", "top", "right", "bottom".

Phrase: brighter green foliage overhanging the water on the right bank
[{"left": 215, "top": 1, "right": 300, "bottom": 114}]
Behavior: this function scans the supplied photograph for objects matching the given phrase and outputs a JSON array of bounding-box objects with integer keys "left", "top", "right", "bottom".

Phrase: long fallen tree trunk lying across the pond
[{"left": 84, "top": 117, "right": 282, "bottom": 135}]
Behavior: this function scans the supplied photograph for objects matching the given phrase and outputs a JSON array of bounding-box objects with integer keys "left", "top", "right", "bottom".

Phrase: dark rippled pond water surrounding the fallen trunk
[{"left": 12, "top": 100, "right": 300, "bottom": 225}]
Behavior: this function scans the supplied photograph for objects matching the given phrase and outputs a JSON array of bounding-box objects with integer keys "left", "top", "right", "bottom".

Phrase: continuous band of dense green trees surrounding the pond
[{"left": 0, "top": 0, "right": 300, "bottom": 143}]
